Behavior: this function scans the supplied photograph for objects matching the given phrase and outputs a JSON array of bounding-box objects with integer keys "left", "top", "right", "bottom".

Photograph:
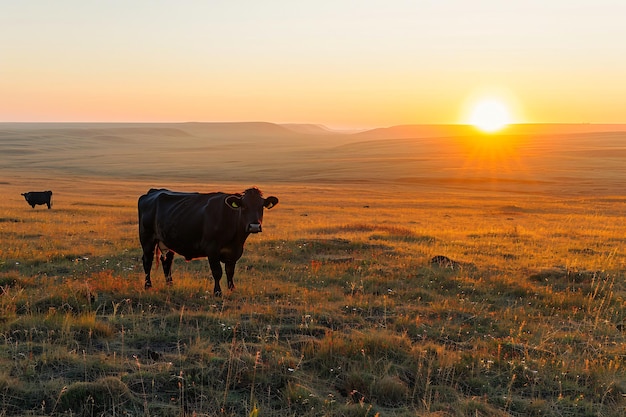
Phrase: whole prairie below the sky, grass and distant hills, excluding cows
[{"left": 0, "top": 123, "right": 626, "bottom": 416}]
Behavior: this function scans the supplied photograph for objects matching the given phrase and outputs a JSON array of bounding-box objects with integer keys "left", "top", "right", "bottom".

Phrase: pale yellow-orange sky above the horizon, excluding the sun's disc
[{"left": 0, "top": 0, "right": 626, "bottom": 128}]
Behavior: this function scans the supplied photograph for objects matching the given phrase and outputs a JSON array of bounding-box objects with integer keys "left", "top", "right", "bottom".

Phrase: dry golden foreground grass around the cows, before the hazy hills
[{"left": 0, "top": 124, "right": 626, "bottom": 417}]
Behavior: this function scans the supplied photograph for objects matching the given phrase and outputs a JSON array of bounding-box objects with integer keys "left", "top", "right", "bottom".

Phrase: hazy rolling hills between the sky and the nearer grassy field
[{"left": 0, "top": 122, "right": 626, "bottom": 194}]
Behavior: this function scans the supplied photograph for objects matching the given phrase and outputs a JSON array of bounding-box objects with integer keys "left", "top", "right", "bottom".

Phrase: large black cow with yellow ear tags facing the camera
[{"left": 138, "top": 188, "right": 278, "bottom": 295}]
